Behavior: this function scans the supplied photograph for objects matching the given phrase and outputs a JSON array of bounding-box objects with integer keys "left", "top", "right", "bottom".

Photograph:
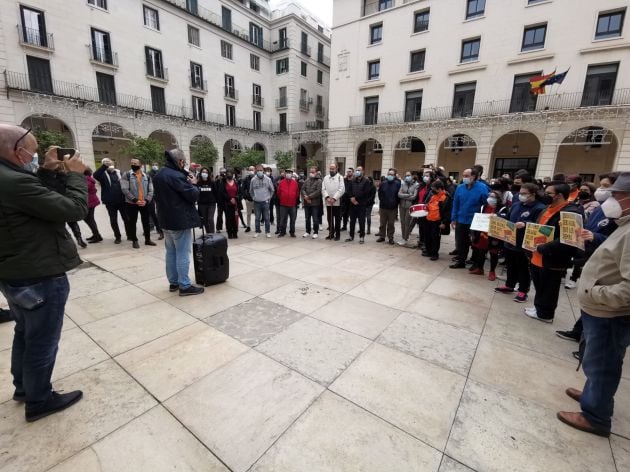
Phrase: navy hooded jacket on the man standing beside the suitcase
[{"left": 153, "top": 151, "right": 201, "bottom": 231}]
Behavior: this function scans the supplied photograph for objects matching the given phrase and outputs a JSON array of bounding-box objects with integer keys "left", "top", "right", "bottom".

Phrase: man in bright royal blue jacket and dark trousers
[{"left": 449, "top": 169, "right": 488, "bottom": 269}]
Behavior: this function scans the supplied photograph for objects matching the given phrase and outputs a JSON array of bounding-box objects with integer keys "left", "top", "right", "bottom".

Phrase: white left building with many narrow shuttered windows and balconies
[{"left": 0, "top": 0, "right": 330, "bottom": 168}]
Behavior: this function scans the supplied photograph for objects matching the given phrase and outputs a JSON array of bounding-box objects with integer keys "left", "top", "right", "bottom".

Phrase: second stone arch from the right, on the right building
[{"left": 488, "top": 130, "right": 540, "bottom": 178}]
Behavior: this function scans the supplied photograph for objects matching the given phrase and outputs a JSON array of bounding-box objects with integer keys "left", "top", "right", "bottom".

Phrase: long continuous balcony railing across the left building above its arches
[{"left": 3, "top": 70, "right": 280, "bottom": 133}]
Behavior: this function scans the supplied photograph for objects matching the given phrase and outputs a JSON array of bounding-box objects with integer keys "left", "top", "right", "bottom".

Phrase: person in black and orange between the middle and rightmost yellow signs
[{"left": 525, "top": 183, "right": 581, "bottom": 323}]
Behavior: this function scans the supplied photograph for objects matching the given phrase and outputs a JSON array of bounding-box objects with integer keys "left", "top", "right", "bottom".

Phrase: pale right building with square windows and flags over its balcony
[{"left": 326, "top": 0, "right": 630, "bottom": 180}]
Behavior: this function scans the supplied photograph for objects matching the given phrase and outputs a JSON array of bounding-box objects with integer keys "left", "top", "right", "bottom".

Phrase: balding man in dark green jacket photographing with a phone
[{"left": 0, "top": 125, "right": 88, "bottom": 421}]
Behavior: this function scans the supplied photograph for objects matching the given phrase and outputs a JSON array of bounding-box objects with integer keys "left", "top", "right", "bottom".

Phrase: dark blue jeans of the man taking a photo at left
[{"left": 0, "top": 274, "right": 70, "bottom": 406}]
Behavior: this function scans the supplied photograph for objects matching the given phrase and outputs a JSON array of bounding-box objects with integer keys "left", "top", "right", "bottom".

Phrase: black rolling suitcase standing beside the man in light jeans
[{"left": 193, "top": 228, "right": 230, "bottom": 287}]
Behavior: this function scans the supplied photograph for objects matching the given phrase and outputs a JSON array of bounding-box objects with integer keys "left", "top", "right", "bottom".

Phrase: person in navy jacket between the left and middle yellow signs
[{"left": 494, "top": 183, "right": 545, "bottom": 303}]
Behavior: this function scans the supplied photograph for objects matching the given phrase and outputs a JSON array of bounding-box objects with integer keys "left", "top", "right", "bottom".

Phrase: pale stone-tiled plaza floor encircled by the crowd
[{"left": 0, "top": 207, "right": 630, "bottom": 472}]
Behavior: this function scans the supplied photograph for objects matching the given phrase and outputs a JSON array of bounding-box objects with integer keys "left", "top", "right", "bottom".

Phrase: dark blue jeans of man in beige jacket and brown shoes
[{"left": 580, "top": 311, "right": 630, "bottom": 431}]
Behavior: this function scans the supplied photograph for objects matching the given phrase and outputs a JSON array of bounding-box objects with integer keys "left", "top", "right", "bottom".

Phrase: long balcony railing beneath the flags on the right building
[{"left": 349, "top": 89, "right": 630, "bottom": 126}]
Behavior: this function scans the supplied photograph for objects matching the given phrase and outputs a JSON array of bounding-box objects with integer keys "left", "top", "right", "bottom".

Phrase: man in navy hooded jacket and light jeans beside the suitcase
[{"left": 153, "top": 149, "right": 204, "bottom": 297}]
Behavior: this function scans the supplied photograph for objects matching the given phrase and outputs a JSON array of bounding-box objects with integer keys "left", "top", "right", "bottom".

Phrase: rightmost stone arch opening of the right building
[{"left": 553, "top": 126, "right": 619, "bottom": 182}]
